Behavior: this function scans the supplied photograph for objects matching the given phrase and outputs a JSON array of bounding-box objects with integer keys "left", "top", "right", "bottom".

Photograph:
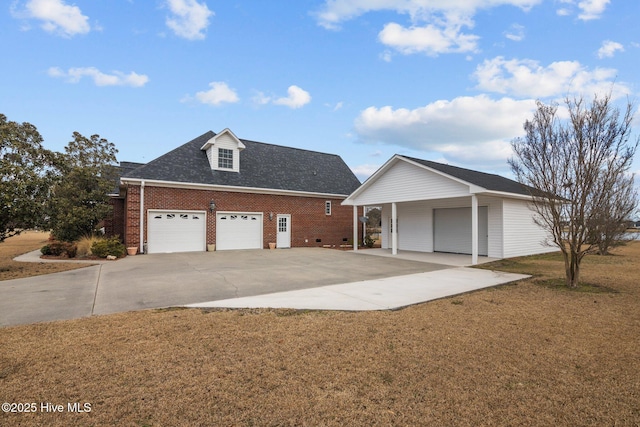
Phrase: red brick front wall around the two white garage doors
[{"left": 125, "top": 186, "right": 362, "bottom": 248}]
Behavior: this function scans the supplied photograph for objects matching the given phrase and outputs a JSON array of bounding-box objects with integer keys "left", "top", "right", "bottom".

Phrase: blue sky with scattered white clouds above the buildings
[{"left": 0, "top": 0, "right": 640, "bottom": 182}]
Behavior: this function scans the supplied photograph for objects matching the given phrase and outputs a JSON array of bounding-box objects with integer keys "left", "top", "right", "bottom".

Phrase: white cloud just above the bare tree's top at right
[{"left": 473, "top": 56, "right": 630, "bottom": 98}]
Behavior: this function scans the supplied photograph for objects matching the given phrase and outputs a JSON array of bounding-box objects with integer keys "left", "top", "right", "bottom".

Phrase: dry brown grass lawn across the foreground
[{"left": 0, "top": 237, "right": 640, "bottom": 426}]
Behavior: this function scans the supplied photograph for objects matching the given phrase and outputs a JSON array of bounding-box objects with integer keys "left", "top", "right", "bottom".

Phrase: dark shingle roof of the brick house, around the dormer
[{"left": 123, "top": 131, "right": 360, "bottom": 195}]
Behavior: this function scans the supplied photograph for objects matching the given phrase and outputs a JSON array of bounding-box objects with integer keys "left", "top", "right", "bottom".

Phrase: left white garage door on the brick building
[{"left": 147, "top": 211, "right": 207, "bottom": 254}]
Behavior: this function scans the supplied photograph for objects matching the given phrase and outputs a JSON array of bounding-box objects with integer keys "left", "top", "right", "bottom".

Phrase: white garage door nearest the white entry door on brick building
[{"left": 216, "top": 212, "right": 262, "bottom": 251}]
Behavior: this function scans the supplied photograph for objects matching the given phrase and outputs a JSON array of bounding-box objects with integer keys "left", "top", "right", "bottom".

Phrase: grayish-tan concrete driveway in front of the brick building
[{"left": 0, "top": 248, "right": 450, "bottom": 326}]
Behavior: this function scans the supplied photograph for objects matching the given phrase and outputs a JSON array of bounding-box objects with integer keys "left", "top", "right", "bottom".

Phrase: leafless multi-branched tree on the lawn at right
[{"left": 509, "top": 93, "right": 640, "bottom": 287}]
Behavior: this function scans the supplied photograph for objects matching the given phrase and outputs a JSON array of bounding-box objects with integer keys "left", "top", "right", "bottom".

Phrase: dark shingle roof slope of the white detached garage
[{"left": 400, "top": 156, "right": 538, "bottom": 196}]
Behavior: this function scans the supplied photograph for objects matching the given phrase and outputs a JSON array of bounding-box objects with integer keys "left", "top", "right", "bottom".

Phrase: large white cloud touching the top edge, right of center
[{"left": 316, "top": 0, "right": 542, "bottom": 56}]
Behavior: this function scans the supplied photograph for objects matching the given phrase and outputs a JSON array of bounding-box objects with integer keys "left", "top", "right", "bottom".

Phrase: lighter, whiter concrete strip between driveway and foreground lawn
[{"left": 187, "top": 267, "right": 530, "bottom": 311}]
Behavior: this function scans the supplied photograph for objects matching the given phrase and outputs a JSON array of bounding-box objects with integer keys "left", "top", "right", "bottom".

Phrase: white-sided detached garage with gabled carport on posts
[{"left": 343, "top": 155, "right": 554, "bottom": 264}]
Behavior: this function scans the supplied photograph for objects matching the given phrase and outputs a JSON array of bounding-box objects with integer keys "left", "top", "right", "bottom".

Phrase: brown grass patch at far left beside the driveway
[{"left": 0, "top": 231, "right": 87, "bottom": 281}]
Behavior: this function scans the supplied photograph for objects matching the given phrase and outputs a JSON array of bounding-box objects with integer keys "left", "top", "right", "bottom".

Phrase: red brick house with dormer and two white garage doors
[{"left": 108, "top": 129, "right": 360, "bottom": 253}]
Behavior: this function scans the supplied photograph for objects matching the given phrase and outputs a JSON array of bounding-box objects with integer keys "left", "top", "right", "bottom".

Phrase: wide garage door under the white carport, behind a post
[{"left": 433, "top": 206, "right": 489, "bottom": 256}]
